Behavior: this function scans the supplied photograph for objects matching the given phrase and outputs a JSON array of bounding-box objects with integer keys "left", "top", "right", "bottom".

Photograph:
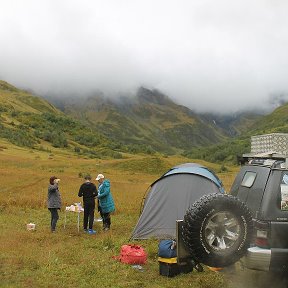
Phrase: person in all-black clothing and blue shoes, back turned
[{"left": 78, "top": 175, "right": 98, "bottom": 234}]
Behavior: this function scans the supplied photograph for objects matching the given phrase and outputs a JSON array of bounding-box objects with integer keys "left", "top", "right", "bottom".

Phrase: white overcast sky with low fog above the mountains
[{"left": 0, "top": 0, "right": 288, "bottom": 113}]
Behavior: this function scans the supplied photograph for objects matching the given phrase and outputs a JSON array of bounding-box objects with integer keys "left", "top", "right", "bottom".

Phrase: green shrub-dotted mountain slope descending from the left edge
[{"left": 0, "top": 81, "right": 121, "bottom": 158}]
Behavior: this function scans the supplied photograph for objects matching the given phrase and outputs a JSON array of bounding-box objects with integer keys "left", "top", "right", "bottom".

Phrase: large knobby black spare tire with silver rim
[{"left": 182, "top": 193, "right": 253, "bottom": 267}]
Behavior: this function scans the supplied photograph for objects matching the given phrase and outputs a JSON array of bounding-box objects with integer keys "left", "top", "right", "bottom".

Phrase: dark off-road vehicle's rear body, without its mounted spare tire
[{"left": 230, "top": 155, "right": 288, "bottom": 272}]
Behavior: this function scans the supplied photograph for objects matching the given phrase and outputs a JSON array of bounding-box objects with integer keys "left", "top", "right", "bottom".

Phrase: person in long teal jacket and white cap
[{"left": 96, "top": 174, "right": 115, "bottom": 231}]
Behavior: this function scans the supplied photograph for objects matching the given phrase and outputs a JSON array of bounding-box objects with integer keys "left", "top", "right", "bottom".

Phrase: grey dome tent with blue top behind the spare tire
[{"left": 131, "top": 163, "right": 225, "bottom": 239}]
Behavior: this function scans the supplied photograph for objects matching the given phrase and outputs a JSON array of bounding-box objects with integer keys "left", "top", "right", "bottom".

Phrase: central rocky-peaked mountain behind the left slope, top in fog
[{"left": 51, "top": 87, "right": 233, "bottom": 153}]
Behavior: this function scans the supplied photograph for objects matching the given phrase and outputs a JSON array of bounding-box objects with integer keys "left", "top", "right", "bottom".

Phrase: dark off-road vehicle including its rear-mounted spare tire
[{"left": 178, "top": 154, "right": 288, "bottom": 277}]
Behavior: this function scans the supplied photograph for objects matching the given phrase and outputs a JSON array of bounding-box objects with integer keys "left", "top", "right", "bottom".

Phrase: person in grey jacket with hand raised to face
[{"left": 47, "top": 176, "right": 61, "bottom": 232}]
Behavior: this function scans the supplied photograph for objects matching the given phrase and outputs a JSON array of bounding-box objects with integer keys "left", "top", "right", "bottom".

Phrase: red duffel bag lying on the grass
[{"left": 119, "top": 244, "right": 147, "bottom": 264}]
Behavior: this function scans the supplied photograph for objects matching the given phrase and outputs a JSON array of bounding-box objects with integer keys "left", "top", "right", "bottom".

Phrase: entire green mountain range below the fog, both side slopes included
[{"left": 0, "top": 81, "right": 288, "bottom": 157}]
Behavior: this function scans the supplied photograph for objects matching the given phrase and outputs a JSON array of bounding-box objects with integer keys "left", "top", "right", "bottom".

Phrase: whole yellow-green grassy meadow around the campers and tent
[{"left": 0, "top": 142, "right": 238, "bottom": 288}]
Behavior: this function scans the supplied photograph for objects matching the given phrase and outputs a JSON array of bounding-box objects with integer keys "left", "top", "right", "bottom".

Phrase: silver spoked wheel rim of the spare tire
[{"left": 204, "top": 211, "right": 240, "bottom": 251}]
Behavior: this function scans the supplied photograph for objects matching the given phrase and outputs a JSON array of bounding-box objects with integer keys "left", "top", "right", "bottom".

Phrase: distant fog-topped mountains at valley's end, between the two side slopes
[{"left": 46, "top": 87, "right": 262, "bottom": 148}]
